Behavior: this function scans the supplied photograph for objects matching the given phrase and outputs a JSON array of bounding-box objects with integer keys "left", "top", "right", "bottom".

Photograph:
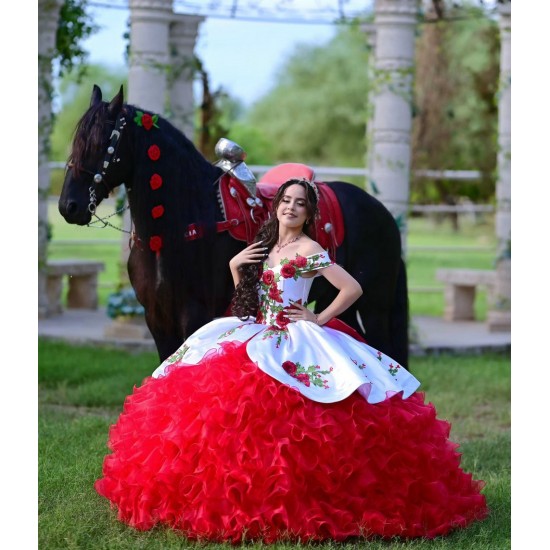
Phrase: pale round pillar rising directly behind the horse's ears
[{"left": 126, "top": 0, "right": 173, "bottom": 115}]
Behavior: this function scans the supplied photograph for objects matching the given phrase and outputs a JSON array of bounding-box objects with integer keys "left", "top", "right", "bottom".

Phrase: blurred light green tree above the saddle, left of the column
[{"left": 245, "top": 26, "right": 369, "bottom": 166}]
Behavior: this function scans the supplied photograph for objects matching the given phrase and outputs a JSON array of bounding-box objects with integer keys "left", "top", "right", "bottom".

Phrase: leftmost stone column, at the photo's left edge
[{"left": 38, "top": 0, "right": 63, "bottom": 318}]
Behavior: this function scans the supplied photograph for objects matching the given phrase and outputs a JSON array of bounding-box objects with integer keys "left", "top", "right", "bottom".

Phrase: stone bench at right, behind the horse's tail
[{"left": 435, "top": 269, "right": 496, "bottom": 321}]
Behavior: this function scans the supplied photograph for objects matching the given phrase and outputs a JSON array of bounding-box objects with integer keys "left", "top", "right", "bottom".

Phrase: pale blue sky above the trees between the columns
[{"left": 84, "top": 5, "right": 344, "bottom": 105}]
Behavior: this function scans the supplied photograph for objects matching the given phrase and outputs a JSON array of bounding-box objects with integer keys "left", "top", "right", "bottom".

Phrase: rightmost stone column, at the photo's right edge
[{"left": 487, "top": 1, "right": 512, "bottom": 332}]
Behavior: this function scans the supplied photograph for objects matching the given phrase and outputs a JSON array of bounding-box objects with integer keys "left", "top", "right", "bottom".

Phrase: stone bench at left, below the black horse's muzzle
[{"left": 46, "top": 260, "right": 105, "bottom": 315}]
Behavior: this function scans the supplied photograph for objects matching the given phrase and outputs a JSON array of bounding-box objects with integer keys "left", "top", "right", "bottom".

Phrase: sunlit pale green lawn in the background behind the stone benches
[{"left": 48, "top": 202, "right": 496, "bottom": 320}]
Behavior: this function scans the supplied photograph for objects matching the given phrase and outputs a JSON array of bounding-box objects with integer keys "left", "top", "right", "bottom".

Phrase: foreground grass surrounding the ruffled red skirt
[{"left": 38, "top": 340, "right": 511, "bottom": 550}]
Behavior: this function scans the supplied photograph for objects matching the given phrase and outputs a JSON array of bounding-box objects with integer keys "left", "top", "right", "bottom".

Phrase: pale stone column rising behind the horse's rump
[{"left": 367, "top": 0, "right": 418, "bottom": 256}]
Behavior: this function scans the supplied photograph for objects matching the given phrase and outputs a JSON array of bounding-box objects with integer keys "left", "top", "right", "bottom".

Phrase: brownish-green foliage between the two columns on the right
[{"left": 411, "top": 3, "right": 500, "bottom": 203}]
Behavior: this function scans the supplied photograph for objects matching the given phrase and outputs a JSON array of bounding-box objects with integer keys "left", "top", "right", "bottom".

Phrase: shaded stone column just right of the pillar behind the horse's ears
[{"left": 168, "top": 15, "right": 205, "bottom": 141}]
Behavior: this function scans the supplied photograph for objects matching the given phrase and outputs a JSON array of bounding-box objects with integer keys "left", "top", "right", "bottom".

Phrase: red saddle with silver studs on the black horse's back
[{"left": 218, "top": 163, "right": 344, "bottom": 259}]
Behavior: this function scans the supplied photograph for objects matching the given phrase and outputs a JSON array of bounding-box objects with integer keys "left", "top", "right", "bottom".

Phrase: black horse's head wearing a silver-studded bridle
[{"left": 58, "top": 85, "right": 130, "bottom": 225}]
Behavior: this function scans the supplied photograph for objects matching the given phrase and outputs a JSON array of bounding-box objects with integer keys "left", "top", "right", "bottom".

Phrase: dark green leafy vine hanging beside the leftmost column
[{"left": 55, "top": 0, "right": 98, "bottom": 77}]
